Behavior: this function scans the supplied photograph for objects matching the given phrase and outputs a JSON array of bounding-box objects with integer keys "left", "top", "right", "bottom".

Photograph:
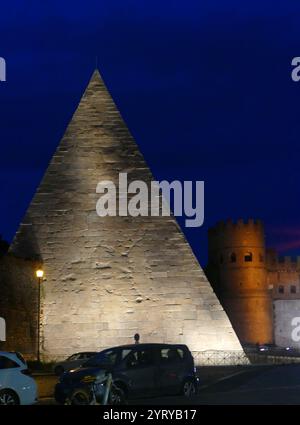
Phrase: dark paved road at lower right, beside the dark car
[{"left": 42, "top": 365, "right": 300, "bottom": 405}]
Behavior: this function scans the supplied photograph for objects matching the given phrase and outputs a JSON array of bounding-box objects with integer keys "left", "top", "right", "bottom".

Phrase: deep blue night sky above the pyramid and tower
[{"left": 0, "top": 0, "right": 300, "bottom": 263}]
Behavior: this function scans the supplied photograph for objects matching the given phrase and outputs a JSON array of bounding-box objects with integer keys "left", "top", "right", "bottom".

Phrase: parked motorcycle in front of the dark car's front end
[{"left": 65, "top": 371, "right": 125, "bottom": 406}]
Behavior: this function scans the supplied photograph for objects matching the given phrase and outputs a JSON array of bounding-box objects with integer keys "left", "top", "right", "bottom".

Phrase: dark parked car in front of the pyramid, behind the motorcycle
[{"left": 55, "top": 344, "right": 198, "bottom": 404}]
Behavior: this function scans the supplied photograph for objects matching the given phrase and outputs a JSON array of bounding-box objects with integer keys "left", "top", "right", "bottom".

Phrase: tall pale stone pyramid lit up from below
[{"left": 10, "top": 71, "right": 244, "bottom": 363}]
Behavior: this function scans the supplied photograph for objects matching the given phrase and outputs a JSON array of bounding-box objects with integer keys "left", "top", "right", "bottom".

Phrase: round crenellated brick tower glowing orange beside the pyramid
[{"left": 207, "top": 220, "right": 273, "bottom": 344}]
